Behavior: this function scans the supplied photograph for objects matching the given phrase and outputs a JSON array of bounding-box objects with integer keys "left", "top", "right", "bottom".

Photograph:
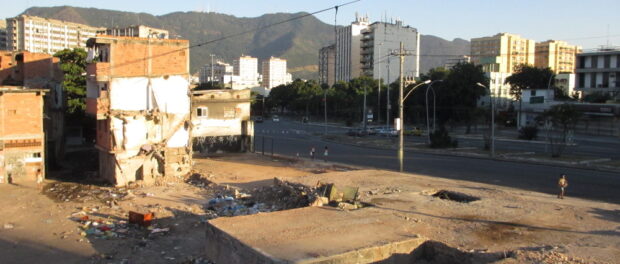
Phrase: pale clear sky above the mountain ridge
[{"left": 0, "top": 0, "right": 620, "bottom": 49}]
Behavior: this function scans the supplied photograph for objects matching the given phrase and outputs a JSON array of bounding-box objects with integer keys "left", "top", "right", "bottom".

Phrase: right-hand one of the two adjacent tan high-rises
[{"left": 534, "top": 40, "right": 581, "bottom": 73}]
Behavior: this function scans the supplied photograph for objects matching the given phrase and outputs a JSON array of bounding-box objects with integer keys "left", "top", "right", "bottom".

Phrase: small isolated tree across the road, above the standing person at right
[{"left": 537, "top": 104, "right": 581, "bottom": 158}]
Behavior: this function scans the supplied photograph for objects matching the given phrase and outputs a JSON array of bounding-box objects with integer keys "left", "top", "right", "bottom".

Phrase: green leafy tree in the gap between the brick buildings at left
[{"left": 54, "top": 48, "right": 87, "bottom": 116}]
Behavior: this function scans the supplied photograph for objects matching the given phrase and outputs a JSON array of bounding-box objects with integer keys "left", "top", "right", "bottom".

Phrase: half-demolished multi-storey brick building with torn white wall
[{"left": 86, "top": 36, "right": 191, "bottom": 186}]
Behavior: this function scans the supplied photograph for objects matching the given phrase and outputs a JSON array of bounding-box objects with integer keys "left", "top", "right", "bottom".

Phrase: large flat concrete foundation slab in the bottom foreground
[{"left": 206, "top": 207, "right": 427, "bottom": 264}]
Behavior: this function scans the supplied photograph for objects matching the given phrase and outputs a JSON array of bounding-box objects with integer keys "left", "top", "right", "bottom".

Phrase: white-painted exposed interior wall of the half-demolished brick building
[{"left": 97, "top": 75, "right": 191, "bottom": 185}]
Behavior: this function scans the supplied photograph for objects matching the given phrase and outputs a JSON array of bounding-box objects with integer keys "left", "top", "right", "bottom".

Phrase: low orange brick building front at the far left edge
[{"left": 0, "top": 86, "right": 45, "bottom": 184}]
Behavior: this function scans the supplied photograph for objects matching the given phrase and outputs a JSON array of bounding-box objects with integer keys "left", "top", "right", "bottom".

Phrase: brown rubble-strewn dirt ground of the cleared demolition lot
[{"left": 0, "top": 154, "right": 620, "bottom": 263}]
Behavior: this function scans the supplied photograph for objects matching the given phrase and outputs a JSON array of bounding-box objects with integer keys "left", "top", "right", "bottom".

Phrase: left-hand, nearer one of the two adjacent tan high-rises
[{"left": 470, "top": 33, "right": 535, "bottom": 73}]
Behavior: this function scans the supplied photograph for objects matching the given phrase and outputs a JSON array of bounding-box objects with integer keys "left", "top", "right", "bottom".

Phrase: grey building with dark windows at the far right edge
[{"left": 575, "top": 47, "right": 620, "bottom": 99}]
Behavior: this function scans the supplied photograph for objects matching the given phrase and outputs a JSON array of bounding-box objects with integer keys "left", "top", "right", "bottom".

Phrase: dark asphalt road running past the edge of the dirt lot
[{"left": 255, "top": 120, "right": 620, "bottom": 203}]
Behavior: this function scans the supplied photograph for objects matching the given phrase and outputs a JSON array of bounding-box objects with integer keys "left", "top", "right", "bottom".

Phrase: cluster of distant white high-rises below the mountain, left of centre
[{"left": 199, "top": 55, "right": 293, "bottom": 95}]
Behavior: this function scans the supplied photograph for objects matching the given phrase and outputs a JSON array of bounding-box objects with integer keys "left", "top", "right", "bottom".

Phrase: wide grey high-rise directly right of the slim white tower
[{"left": 360, "top": 20, "right": 420, "bottom": 83}]
